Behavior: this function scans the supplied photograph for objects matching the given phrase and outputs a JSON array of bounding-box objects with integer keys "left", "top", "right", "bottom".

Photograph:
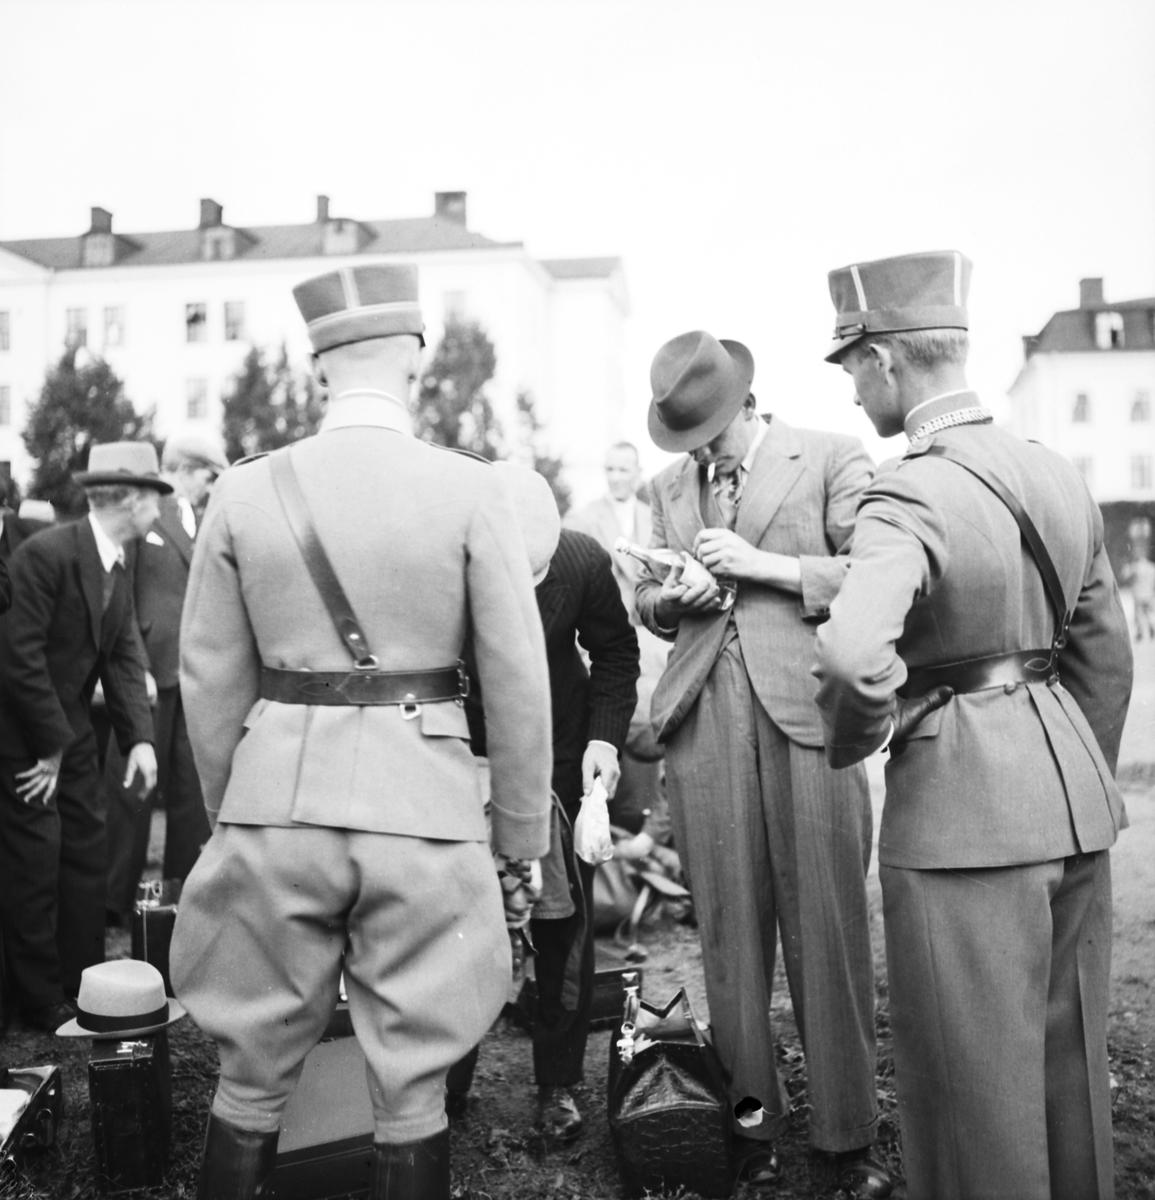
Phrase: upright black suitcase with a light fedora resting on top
[{"left": 88, "top": 1030, "right": 173, "bottom": 1194}]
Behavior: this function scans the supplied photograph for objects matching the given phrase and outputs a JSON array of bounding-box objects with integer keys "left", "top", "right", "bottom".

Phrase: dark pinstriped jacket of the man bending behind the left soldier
[{"left": 468, "top": 529, "right": 638, "bottom": 804}]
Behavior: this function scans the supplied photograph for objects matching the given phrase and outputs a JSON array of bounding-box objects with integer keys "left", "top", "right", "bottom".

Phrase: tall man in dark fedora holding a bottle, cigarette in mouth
[{"left": 638, "top": 332, "right": 891, "bottom": 1196}]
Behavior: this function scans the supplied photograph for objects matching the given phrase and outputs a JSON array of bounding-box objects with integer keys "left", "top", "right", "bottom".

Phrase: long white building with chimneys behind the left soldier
[{"left": 0, "top": 192, "right": 629, "bottom": 497}]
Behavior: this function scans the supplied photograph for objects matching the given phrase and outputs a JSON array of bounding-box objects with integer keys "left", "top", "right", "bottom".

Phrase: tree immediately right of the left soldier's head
[{"left": 415, "top": 318, "right": 503, "bottom": 461}]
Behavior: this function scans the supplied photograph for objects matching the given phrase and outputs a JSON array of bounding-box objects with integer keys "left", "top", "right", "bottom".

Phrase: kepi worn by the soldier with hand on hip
[{"left": 826, "top": 250, "right": 971, "bottom": 362}]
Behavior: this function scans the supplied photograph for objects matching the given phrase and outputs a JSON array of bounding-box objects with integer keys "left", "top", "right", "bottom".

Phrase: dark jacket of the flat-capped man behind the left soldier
[{"left": 131, "top": 496, "right": 192, "bottom": 688}]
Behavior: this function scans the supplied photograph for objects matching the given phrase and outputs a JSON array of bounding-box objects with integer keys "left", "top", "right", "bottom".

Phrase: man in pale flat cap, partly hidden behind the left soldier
[{"left": 104, "top": 426, "right": 228, "bottom": 917}]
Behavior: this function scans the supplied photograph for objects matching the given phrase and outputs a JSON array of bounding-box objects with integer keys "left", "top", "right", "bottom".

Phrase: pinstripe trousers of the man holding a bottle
[{"left": 666, "top": 628, "right": 878, "bottom": 1152}]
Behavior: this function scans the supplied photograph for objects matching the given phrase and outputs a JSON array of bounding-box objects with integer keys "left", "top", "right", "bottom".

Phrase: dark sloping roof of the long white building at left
[{"left": 0, "top": 216, "right": 521, "bottom": 271}]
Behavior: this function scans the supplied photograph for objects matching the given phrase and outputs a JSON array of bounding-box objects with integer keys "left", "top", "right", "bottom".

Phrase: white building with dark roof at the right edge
[{"left": 1010, "top": 280, "right": 1155, "bottom": 504}]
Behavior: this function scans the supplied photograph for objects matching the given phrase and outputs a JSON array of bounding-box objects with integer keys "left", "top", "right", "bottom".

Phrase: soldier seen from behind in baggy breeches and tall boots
[{"left": 172, "top": 265, "right": 550, "bottom": 1200}]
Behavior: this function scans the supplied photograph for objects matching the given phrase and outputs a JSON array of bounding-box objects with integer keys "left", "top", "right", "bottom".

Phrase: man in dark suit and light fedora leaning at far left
[{"left": 0, "top": 442, "right": 159, "bottom": 1028}]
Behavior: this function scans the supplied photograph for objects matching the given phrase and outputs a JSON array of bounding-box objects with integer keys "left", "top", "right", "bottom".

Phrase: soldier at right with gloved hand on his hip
[{"left": 814, "top": 251, "right": 1131, "bottom": 1200}]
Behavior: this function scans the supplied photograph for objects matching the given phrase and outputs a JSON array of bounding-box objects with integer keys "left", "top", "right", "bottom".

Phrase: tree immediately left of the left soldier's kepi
[{"left": 221, "top": 344, "right": 323, "bottom": 462}]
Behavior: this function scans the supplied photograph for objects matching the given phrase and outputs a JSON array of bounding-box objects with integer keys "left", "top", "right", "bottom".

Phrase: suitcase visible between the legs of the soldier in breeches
[{"left": 268, "top": 1004, "right": 373, "bottom": 1200}]
